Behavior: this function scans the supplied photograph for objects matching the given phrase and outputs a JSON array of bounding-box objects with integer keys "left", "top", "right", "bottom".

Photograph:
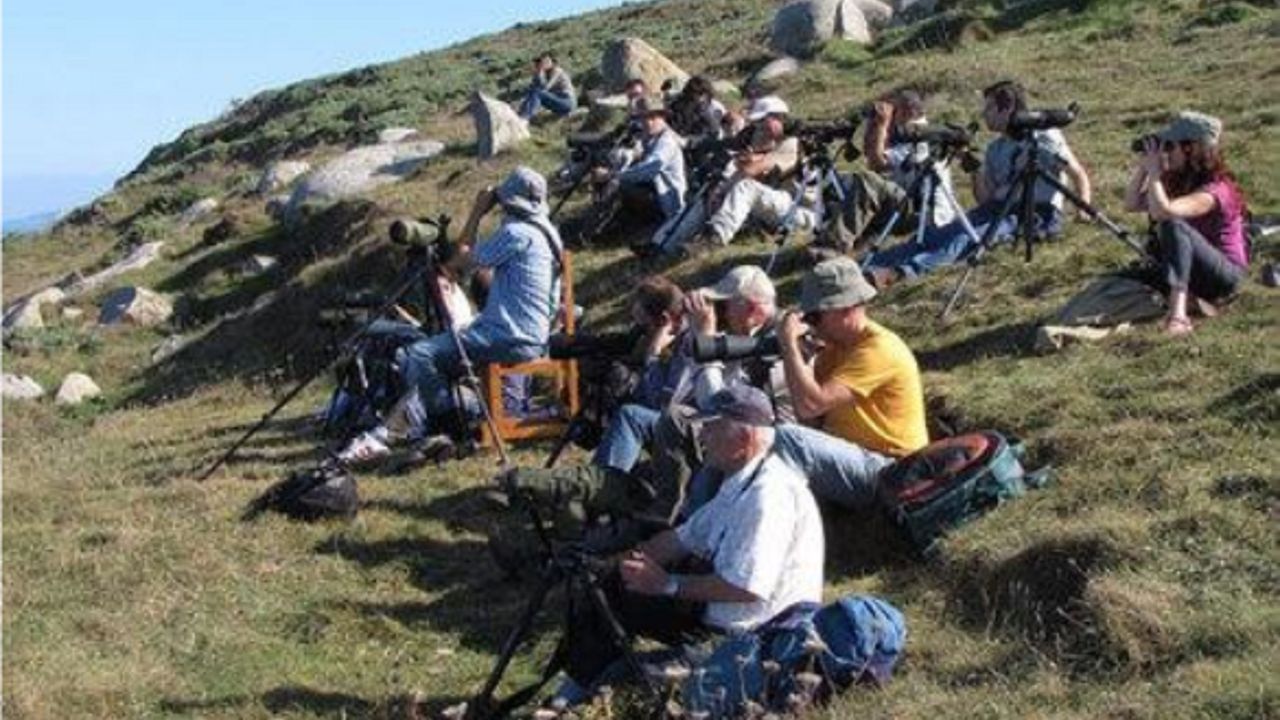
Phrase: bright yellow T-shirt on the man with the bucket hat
[{"left": 814, "top": 320, "right": 929, "bottom": 457}]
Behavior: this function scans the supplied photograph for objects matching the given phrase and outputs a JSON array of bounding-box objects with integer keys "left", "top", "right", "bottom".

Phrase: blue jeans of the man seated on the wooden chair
[{"left": 401, "top": 329, "right": 541, "bottom": 438}]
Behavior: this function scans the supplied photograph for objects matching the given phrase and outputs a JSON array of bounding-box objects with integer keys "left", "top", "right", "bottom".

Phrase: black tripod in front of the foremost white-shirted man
[{"left": 466, "top": 496, "right": 658, "bottom": 720}]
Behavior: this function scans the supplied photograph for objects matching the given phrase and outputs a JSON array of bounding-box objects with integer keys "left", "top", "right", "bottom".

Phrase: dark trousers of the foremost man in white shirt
[{"left": 564, "top": 573, "right": 714, "bottom": 688}]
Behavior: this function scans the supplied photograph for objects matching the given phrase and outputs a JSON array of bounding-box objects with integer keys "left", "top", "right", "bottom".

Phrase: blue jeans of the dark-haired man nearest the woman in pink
[{"left": 863, "top": 202, "right": 1062, "bottom": 278}]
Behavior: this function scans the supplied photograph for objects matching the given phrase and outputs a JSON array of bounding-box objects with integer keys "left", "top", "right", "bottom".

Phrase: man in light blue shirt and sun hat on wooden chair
[{"left": 338, "top": 167, "right": 563, "bottom": 464}]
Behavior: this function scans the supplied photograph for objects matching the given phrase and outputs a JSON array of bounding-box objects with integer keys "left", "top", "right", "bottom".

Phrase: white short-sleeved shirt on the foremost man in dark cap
[{"left": 676, "top": 451, "right": 826, "bottom": 632}]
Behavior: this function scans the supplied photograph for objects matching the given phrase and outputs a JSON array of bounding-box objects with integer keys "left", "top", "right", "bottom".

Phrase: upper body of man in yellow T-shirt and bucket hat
[{"left": 778, "top": 258, "right": 929, "bottom": 457}]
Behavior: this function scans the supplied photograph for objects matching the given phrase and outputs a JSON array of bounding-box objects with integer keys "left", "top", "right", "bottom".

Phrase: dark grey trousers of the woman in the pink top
[{"left": 1156, "top": 219, "right": 1245, "bottom": 300}]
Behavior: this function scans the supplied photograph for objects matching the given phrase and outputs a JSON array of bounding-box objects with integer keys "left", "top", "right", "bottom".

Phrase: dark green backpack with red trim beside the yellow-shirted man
[{"left": 879, "top": 430, "right": 1050, "bottom": 556}]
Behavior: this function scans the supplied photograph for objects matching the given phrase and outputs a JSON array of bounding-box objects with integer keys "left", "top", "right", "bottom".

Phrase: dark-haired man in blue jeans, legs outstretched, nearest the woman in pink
[{"left": 863, "top": 81, "right": 1092, "bottom": 290}]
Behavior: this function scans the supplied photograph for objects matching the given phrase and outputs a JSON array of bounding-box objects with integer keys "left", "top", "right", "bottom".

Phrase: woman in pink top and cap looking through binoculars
[{"left": 1125, "top": 111, "right": 1249, "bottom": 334}]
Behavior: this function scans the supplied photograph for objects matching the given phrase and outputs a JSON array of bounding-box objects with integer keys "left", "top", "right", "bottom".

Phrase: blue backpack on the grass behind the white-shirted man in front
[{"left": 680, "top": 594, "right": 906, "bottom": 717}]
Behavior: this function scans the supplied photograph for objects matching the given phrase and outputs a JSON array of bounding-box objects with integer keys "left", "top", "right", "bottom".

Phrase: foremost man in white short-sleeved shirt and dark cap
[{"left": 558, "top": 384, "right": 824, "bottom": 702}]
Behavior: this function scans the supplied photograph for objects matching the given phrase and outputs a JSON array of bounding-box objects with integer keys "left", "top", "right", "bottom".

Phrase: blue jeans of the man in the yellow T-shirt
[{"left": 681, "top": 423, "right": 895, "bottom": 518}]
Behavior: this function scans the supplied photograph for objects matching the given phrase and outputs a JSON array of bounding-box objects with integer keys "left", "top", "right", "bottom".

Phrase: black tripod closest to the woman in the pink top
[{"left": 938, "top": 132, "right": 1147, "bottom": 319}]
